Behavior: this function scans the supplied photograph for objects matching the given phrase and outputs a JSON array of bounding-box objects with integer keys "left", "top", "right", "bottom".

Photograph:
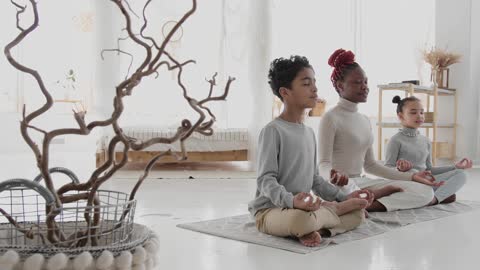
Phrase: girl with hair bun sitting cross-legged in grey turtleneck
[{"left": 385, "top": 96, "right": 472, "bottom": 205}]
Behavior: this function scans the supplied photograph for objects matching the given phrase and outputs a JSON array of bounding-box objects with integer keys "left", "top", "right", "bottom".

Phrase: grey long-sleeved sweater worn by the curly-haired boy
[{"left": 248, "top": 118, "right": 346, "bottom": 216}]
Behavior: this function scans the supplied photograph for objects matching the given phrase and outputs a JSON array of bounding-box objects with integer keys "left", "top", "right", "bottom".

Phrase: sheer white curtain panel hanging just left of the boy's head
[{"left": 221, "top": 0, "right": 272, "bottom": 168}]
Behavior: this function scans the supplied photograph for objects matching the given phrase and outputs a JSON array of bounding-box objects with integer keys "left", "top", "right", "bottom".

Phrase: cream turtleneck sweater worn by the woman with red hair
[{"left": 318, "top": 98, "right": 412, "bottom": 181}]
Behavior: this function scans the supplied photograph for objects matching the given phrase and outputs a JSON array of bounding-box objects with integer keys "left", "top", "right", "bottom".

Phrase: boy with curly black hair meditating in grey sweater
[{"left": 248, "top": 56, "right": 373, "bottom": 247}]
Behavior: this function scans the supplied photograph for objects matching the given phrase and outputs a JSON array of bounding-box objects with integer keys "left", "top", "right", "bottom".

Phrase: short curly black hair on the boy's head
[{"left": 268, "top": 55, "right": 312, "bottom": 101}]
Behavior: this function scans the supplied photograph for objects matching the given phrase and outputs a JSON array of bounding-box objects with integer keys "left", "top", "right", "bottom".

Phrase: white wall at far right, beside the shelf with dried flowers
[{"left": 435, "top": 0, "right": 480, "bottom": 158}]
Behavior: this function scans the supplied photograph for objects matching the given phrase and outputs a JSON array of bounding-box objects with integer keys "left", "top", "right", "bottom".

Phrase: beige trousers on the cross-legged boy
[{"left": 255, "top": 206, "right": 364, "bottom": 237}]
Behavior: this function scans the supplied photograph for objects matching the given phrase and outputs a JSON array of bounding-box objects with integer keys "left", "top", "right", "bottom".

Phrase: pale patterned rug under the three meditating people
[{"left": 177, "top": 201, "right": 480, "bottom": 254}]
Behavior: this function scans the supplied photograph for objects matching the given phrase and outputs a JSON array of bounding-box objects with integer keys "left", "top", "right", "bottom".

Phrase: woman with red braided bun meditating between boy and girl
[{"left": 318, "top": 49, "right": 441, "bottom": 211}]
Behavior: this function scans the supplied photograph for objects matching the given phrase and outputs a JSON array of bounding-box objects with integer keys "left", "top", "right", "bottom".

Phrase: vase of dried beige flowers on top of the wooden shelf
[{"left": 423, "top": 48, "right": 462, "bottom": 88}]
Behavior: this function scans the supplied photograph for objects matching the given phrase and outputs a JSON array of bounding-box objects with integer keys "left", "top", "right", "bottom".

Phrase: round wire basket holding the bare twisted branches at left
[{"left": 0, "top": 179, "right": 136, "bottom": 254}]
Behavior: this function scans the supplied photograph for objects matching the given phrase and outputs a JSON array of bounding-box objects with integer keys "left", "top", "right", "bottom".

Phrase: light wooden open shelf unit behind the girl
[{"left": 377, "top": 83, "right": 457, "bottom": 164}]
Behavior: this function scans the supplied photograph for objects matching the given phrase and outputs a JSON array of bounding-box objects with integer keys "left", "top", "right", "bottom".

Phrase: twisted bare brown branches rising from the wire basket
[{"left": 0, "top": 0, "right": 234, "bottom": 247}]
